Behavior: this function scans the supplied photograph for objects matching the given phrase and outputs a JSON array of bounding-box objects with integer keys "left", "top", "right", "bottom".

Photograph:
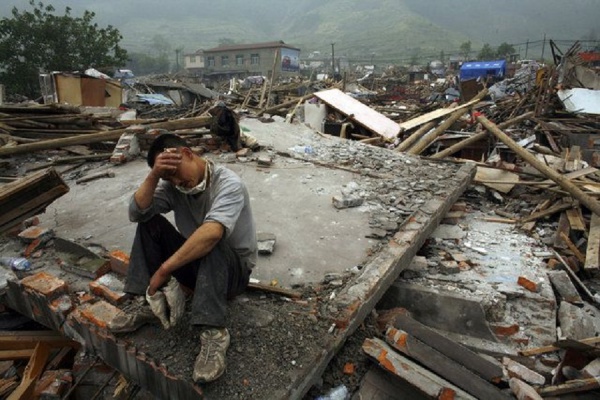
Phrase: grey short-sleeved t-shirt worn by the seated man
[{"left": 129, "top": 165, "right": 257, "bottom": 268}]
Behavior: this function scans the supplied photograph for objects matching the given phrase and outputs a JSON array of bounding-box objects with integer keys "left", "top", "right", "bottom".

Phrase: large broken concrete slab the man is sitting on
[{"left": 0, "top": 120, "right": 475, "bottom": 399}]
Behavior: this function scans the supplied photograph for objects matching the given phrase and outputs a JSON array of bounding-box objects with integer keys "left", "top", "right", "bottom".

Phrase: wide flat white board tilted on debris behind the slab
[{"left": 315, "top": 89, "right": 400, "bottom": 140}]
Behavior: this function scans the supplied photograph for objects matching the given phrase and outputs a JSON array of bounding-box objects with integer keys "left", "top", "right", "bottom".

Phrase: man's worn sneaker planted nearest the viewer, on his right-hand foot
[{"left": 192, "top": 328, "right": 230, "bottom": 383}]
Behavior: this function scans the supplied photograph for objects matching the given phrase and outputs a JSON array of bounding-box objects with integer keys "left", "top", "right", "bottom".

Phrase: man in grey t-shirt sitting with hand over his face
[{"left": 109, "top": 133, "right": 257, "bottom": 382}]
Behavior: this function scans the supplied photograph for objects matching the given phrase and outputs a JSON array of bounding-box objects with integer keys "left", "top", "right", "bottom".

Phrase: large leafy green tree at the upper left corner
[{"left": 0, "top": 0, "right": 127, "bottom": 98}]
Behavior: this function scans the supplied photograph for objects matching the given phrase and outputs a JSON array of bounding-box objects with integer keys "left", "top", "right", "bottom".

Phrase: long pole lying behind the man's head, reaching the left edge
[{"left": 0, "top": 117, "right": 212, "bottom": 157}]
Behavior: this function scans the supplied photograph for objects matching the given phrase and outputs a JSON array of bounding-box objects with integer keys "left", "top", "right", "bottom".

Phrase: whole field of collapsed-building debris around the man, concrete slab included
[{"left": 0, "top": 41, "right": 600, "bottom": 399}]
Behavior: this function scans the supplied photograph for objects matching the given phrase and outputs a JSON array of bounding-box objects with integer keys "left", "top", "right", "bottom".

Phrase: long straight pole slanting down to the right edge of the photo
[{"left": 477, "top": 115, "right": 600, "bottom": 216}]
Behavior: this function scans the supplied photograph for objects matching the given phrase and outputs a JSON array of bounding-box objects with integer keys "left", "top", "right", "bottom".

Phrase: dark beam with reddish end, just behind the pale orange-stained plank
[{"left": 385, "top": 327, "right": 509, "bottom": 399}]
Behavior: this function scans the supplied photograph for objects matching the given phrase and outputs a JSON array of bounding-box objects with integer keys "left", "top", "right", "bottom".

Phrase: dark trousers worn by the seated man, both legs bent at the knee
[{"left": 125, "top": 215, "right": 251, "bottom": 327}]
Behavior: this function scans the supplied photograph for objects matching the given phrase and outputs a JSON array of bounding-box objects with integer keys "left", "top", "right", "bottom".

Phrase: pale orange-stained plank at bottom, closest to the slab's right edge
[{"left": 362, "top": 339, "right": 475, "bottom": 400}]
